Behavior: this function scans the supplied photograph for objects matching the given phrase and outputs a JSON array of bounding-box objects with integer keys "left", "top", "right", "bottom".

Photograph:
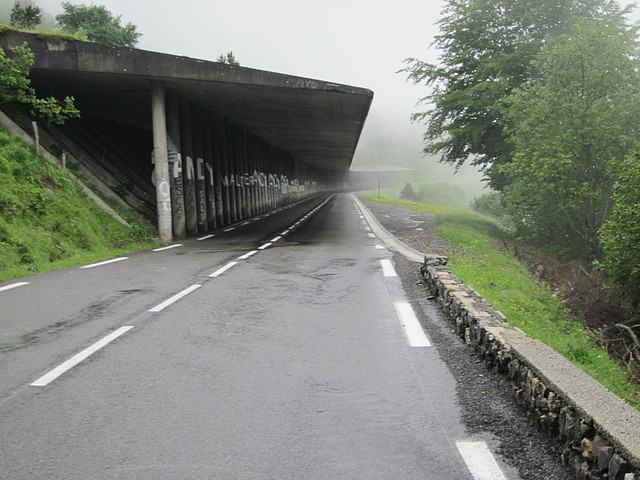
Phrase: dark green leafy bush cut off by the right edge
[{"left": 600, "top": 152, "right": 640, "bottom": 307}]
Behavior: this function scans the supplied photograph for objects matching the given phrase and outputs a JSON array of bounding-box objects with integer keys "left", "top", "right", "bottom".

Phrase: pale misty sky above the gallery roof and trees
[{"left": 0, "top": 0, "right": 637, "bottom": 177}]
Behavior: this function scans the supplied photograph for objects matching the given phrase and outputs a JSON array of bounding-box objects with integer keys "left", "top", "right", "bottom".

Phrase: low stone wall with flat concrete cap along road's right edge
[{"left": 358, "top": 197, "right": 640, "bottom": 480}]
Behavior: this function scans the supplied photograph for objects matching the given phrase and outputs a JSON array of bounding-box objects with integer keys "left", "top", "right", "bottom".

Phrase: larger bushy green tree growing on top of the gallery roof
[{"left": 56, "top": 2, "right": 142, "bottom": 47}]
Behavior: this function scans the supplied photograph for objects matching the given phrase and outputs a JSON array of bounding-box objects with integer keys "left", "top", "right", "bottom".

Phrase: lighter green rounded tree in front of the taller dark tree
[{"left": 499, "top": 21, "right": 640, "bottom": 261}]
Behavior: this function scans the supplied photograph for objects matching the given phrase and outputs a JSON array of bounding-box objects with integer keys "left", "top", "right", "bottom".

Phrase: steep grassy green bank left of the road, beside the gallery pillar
[{"left": 0, "top": 125, "right": 157, "bottom": 281}]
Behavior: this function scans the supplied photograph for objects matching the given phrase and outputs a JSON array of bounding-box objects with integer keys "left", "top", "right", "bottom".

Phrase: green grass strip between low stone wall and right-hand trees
[{"left": 365, "top": 190, "right": 640, "bottom": 409}]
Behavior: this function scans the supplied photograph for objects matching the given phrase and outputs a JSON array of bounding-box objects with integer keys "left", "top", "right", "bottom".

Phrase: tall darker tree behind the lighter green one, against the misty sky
[{"left": 403, "top": 0, "right": 626, "bottom": 190}]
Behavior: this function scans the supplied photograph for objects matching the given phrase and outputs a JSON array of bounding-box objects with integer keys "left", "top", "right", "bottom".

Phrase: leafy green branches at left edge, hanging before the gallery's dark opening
[{"left": 0, "top": 43, "right": 80, "bottom": 124}]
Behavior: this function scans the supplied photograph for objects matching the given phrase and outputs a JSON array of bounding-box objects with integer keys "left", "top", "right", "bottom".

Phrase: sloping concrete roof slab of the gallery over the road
[{"left": 0, "top": 31, "right": 373, "bottom": 171}]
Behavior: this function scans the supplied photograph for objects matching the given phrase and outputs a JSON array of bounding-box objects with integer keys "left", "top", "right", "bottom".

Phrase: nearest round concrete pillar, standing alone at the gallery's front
[{"left": 151, "top": 84, "right": 173, "bottom": 243}]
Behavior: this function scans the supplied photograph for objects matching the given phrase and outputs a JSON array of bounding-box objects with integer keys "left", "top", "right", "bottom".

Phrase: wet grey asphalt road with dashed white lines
[{"left": 0, "top": 195, "right": 568, "bottom": 480}]
